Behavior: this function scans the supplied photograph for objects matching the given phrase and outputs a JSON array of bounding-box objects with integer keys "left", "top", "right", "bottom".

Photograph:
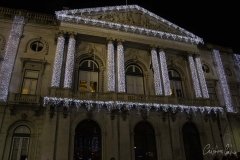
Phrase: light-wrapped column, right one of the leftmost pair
[{"left": 64, "top": 35, "right": 76, "bottom": 88}]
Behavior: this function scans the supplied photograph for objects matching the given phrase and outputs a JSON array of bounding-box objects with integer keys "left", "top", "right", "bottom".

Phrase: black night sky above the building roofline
[{"left": 0, "top": 0, "right": 240, "bottom": 53}]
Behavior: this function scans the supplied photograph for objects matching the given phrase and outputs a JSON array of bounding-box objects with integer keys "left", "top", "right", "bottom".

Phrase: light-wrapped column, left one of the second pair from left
[{"left": 107, "top": 41, "right": 115, "bottom": 92}]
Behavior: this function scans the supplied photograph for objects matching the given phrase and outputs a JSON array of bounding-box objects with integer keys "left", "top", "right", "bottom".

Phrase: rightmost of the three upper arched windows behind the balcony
[{"left": 168, "top": 69, "right": 184, "bottom": 97}]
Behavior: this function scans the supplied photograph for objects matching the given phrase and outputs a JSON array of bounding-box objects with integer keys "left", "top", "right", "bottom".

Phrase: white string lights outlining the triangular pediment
[{"left": 55, "top": 5, "right": 203, "bottom": 44}]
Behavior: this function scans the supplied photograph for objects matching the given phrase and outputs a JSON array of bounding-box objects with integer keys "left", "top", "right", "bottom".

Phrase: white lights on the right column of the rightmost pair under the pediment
[{"left": 195, "top": 57, "right": 209, "bottom": 98}]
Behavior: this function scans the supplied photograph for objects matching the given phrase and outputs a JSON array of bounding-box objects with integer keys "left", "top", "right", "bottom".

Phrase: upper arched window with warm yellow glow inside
[{"left": 78, "top": 59, "right": 99, "bottom": 92}]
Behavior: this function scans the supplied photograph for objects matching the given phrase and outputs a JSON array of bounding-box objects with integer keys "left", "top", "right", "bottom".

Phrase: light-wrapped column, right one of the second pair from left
[{"left": 117, "top": 42, "right": 125, "bottom": 92}]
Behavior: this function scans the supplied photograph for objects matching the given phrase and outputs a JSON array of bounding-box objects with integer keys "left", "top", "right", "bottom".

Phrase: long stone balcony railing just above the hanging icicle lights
[{"left": 49, "top": 88, "right": 219, "bottom": 106}]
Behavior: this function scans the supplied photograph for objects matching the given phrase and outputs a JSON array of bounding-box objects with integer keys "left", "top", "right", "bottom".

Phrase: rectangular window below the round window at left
[{"left": 22, "top": 70, "right": 39, "bottom": 95}]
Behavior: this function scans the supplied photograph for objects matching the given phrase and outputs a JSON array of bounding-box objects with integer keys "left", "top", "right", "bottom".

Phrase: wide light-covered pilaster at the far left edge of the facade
[{"left": 0, "top": 16, "right": 24, "bottom": 102}]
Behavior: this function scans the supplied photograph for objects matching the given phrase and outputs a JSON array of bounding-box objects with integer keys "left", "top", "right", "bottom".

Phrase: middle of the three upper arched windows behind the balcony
[{"left": 126, "top": 64, "right": 144, "bottom": 94}]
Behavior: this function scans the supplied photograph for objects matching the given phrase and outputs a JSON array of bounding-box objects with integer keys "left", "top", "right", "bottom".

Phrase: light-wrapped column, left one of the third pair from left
[{"left": 151, "top": 48, "right": 163, "bottom": 95}]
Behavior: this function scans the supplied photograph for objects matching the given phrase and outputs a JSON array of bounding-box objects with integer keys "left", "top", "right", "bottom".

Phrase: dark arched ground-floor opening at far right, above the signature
[{"left": 182, "top": 123, "right": 203, "bottom": 160}]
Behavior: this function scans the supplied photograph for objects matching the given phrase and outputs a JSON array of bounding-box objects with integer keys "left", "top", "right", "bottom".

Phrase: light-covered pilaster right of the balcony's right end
[{"left": 212, "top": 49, "right": 234, "bottom": 112}]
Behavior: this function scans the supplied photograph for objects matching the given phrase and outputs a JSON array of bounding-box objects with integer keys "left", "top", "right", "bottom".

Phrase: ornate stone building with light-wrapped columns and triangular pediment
[{"left": 0, "top": 5, "right": 240, "bottom": 160}]
